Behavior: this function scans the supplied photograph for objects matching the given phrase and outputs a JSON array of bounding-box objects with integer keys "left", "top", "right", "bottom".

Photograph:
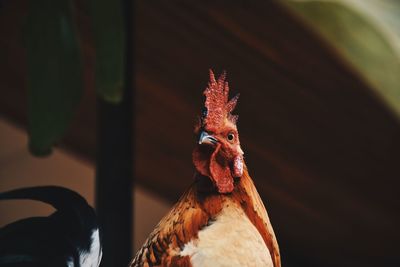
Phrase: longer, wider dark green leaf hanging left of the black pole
[{"left": 26, "top": 0, "right": 83, "bottom": 156}]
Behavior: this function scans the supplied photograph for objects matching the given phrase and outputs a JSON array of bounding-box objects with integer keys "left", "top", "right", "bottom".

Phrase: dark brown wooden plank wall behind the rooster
[{"left": 0, "top": 0, "right": 400, "bottom": 266}]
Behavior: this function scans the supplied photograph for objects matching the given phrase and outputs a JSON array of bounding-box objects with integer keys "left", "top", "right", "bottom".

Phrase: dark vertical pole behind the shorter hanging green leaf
[{"left": 96, "top": 0, "right": 134, "bottom": 267}]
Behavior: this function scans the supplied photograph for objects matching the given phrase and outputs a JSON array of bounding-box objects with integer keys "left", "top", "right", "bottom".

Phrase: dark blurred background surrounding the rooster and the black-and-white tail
[{"left": 0, "top": 0, "right": 400, "bottom": 266}]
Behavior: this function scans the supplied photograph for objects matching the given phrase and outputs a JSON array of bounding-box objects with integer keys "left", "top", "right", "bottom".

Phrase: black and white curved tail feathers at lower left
[{"left": 0, "top": 186, "right": 102, "bottom": 267}]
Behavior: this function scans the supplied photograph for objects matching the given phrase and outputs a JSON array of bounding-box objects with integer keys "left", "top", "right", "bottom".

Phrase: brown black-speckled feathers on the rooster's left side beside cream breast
[{"left": 130, "top": 182, "right": 222, "bottom": 267}]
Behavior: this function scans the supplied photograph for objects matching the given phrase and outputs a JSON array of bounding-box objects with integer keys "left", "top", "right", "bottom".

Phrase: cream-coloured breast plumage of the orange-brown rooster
[{"left": 180, "top": 202, "right": 273, "bottom": 267}]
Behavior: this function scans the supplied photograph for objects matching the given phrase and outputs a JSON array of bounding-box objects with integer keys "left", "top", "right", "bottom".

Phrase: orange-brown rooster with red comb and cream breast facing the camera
[{"left": 130, "top": 70, "right": 281, "bottom": 267}]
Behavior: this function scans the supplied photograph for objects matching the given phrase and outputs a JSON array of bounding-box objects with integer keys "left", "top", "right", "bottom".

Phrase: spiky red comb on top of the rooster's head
[{"left": 202, "top": 70, "right": 239, "bottom": 128}]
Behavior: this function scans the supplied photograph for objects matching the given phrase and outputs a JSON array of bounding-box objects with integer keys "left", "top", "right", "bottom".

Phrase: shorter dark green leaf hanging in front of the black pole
[{"left": 89, "top": 0, "right": 125, "bottom": 103}]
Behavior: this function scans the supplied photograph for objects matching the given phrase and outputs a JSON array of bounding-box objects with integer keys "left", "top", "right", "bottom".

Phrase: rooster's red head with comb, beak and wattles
[{"left": 193, "top": 70, "right": 244, "bottom": 193}]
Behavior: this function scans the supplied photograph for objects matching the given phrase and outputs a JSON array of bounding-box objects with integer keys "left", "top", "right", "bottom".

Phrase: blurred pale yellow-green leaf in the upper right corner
[{"left": 284, "top": 0, "right": 400, "bottom": 117}]
